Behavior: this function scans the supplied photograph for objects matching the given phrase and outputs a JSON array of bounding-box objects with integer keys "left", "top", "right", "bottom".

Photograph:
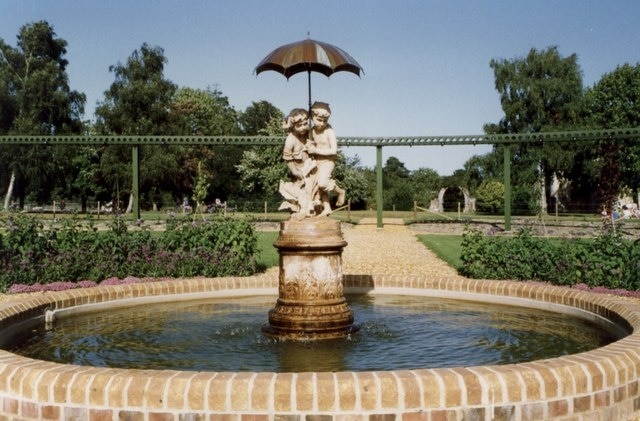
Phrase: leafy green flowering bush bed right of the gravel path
[{"left": 460, "top": 225, "right": 640, "bottom": 290}]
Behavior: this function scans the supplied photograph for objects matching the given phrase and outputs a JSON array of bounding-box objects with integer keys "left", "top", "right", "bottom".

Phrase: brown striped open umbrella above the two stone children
[{"left": 255, "top": 38, "right": 364, "bottom": 109}]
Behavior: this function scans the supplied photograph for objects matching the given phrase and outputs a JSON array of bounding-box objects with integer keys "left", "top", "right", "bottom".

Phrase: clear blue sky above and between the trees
[{"left": 0, "top": 0, "right": 640, "bottom": 175}]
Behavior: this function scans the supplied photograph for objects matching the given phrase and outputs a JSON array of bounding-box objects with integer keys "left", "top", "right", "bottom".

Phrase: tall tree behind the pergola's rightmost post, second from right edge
[{"left": 484, "top": 47, "right": 582, "bottom": 212}]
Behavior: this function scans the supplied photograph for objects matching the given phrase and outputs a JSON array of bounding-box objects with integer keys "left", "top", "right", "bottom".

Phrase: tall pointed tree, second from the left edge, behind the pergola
[{"left": 96, "top": 43, "right": 179, "bottom": 209}]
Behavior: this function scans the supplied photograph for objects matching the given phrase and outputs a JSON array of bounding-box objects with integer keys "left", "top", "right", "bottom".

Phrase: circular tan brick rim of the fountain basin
[{"left": 0, "top": 272, "right": 640, "bottom": 420}]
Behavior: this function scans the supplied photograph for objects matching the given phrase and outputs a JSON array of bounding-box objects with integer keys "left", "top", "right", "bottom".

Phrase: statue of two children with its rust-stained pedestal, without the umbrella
[{"left": 263, "top": 103, "right": 357, "bottom": 340}]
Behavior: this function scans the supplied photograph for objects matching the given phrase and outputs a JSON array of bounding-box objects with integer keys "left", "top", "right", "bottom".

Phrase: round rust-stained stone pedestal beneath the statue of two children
[{"left": 263, "top": 217, "right": 356, "bottom": 340}]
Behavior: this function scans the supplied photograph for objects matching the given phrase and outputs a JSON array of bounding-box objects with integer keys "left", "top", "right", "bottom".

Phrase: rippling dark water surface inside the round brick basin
[{"left": 10, "top": 295, "right": 619, "bottom": 372}]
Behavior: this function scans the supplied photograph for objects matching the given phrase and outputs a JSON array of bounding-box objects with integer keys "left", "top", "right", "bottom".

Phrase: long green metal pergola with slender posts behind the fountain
[{"left": 0, "top": 127, "right": 640, "bottom": 231}]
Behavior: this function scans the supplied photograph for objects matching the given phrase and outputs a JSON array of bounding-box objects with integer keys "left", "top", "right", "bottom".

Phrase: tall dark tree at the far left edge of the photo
[{"left": 0, "top": 21, "right": 86, "bottom": 209}]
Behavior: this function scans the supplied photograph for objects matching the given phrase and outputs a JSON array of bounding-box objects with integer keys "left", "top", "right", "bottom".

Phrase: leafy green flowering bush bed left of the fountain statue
[{"left": 0, "top": 216, "right": 258, "bottom": 291}]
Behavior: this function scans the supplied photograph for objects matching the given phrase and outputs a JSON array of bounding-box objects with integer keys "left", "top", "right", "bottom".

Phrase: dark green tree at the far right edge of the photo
[{"left": 584, "top": 64, "right": 640, "bottom": 209}]
